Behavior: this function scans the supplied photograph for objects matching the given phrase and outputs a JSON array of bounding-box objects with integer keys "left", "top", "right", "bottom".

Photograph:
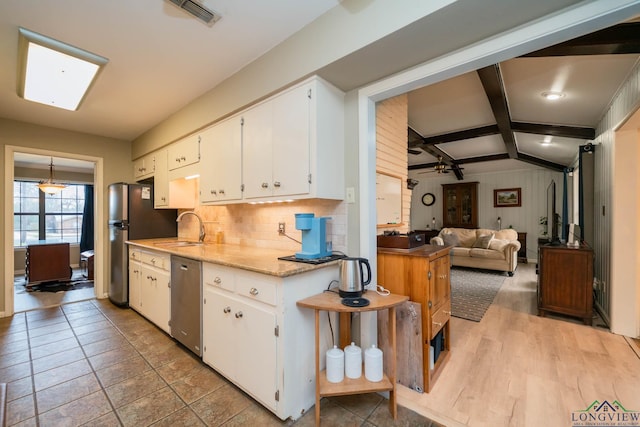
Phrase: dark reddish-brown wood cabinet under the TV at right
[{"left": 538, "top": 245, "right": 593, "bottom": 325}]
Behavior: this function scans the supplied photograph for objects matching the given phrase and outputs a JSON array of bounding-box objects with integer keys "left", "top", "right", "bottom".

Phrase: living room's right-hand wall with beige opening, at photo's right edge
[{"left": 593, "top": 58, "right": 640, "bottom": 336}]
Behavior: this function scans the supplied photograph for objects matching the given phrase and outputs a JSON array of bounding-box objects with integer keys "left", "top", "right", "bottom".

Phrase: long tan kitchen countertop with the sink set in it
[{"left": 127, "top": 238, "right": 338, "bottom": 277}]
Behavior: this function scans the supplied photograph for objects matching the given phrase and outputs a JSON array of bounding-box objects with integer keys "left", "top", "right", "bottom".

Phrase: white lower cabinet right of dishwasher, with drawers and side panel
[{"left": 202, "top": 263, "right": 338, "bottom": 420}]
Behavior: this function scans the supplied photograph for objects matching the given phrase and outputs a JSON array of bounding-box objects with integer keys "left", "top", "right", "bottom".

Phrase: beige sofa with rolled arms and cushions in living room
[{"left": 431, "top": 228, "right": 520, "bottom": 276}]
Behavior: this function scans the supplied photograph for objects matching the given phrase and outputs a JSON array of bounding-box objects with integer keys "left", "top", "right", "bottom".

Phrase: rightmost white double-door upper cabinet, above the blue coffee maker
[{"left": 242, "top": 77, "right": 344, "bottom": 201}]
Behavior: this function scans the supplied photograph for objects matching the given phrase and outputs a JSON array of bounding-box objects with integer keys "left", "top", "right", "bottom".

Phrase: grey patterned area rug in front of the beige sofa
[{"left": 451, "top": 267, "right": 506, "bottom": 322}]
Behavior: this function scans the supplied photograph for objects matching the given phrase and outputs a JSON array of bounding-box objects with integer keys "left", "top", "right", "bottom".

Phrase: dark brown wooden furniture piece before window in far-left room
[{"left": 25, "top": 243, "right": 72, "bottom": 285}]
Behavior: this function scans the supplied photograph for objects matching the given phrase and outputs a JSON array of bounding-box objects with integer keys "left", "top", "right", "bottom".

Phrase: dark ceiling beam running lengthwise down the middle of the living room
[{"left": 477, "top": 64, "right": 518, "bottom": 159}]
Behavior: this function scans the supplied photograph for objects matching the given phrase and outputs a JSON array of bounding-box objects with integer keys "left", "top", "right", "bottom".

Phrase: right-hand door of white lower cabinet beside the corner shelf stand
[{"left": 231, "top": 301, "right": 278, "bottom": 410}]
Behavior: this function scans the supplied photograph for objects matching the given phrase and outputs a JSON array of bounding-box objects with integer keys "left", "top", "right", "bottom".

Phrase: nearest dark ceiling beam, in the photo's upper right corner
[{"left": 522, "top": 22, "right": 640, "bottom": 57}]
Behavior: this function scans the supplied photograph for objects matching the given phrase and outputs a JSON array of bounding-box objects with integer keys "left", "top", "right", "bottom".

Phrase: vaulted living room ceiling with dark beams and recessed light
[{"left": 408, "top": 22, "right": 640, "bottom": 179}]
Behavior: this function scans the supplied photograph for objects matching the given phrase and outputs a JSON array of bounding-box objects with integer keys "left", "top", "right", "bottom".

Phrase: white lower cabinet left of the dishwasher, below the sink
[{"left": 129, "top": 248, "right": 171, "bottom": 334}]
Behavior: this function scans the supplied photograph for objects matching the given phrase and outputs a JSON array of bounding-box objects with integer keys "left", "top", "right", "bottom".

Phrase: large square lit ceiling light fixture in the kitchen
[{"left": 18, "top": 28, "right": 109, "bottom": 111}]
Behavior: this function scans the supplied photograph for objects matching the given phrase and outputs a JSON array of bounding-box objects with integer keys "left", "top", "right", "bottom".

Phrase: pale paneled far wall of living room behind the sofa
[{"left": 409, "top": 168, "right": 572, "bottom": 262}]
